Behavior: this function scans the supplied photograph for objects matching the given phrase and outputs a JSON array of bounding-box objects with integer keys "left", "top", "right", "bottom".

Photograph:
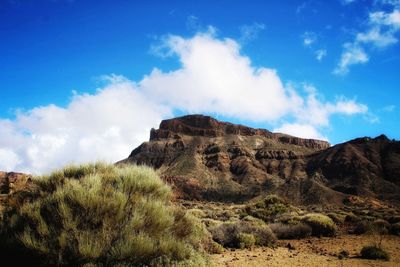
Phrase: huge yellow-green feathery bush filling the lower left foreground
[{"left": 1, "top": 163, "right": 207, "bottom": 266}]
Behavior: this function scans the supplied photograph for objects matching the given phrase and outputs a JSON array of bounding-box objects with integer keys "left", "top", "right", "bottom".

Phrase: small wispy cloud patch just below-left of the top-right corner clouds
[{"left": 333, "top": 43, "right": 369, "bottom": 75}]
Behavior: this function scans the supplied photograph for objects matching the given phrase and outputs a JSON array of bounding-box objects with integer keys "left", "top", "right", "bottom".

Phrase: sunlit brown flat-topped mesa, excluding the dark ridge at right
[{"left": 119, "top": 115, "right": 346, "bottom": 204}]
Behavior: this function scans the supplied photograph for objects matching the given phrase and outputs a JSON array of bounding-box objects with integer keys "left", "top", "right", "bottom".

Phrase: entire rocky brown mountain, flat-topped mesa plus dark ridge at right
[{"left": 117, "top": 115, "right": 400, "bottom": 205}]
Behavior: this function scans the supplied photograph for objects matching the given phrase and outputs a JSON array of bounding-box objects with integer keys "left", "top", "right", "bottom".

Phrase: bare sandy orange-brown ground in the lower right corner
[{"left": 212, "top": 235, "right": 400, "bottom": 267}]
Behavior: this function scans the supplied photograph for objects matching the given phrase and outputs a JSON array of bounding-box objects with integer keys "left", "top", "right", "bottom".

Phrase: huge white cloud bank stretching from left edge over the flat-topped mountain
[{"left": 0, "top": 28, "right": 367, "bottom": 173}]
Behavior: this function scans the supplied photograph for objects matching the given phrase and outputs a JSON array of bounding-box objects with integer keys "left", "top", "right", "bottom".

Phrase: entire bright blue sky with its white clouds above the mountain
[{"left": 0, "top": 0, "right": 400, "bottom": 172}]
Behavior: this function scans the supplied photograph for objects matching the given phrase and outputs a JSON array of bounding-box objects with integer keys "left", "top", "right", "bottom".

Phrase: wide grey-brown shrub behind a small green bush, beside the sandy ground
[{"left": 210, "top": 221, "right": 276, "bottom": 248}]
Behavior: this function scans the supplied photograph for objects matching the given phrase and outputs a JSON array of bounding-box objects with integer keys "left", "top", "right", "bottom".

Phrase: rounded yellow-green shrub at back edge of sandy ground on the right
[{"left": 302, "top": 213, "right": 337, "bottom": 236}]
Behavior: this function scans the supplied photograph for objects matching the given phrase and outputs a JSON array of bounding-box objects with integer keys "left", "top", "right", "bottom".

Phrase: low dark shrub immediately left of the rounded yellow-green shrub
[{"left": 270, "top": 223, "right": 312, "bottom": 239}]
